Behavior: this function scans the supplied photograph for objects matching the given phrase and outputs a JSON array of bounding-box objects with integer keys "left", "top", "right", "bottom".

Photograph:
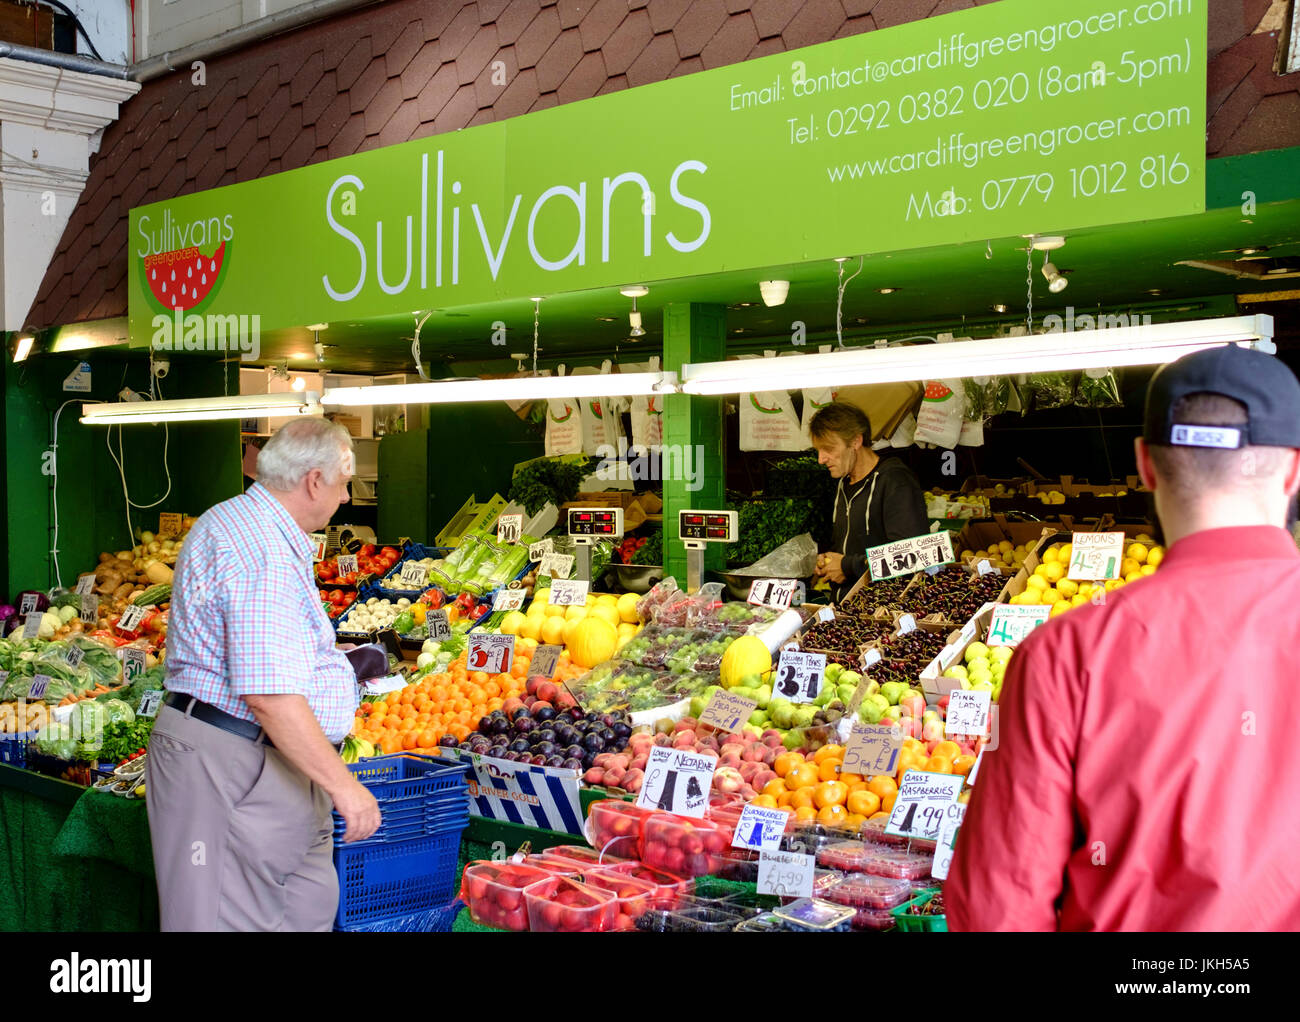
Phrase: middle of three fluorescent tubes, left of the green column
[{"left": 321, "top": 372, "right": 677, "bottom": 407}]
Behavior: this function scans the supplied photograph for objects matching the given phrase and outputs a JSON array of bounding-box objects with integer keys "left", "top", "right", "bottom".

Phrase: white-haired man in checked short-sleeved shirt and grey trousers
[{"left": 146, "top": 419, "right": 380, "bottom": 931}]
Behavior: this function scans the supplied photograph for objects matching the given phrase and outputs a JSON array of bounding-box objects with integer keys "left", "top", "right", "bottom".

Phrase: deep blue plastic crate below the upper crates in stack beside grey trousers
[{"left": 334, "top": 830, "right": 463, "bottom": 928}]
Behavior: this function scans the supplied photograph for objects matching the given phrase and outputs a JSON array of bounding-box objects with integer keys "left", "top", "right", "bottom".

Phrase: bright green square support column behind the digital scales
[{"left": 663, "top": 303, "right": 727, "bottom": 588}]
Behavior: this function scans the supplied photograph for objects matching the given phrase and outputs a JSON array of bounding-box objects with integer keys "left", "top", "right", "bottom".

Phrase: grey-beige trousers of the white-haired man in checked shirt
[{"left": 146, "top": 705, "right": 338, "bottom": 932}]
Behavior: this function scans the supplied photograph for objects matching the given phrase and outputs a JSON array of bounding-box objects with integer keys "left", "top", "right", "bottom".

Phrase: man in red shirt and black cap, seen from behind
[{"left": 945, "top": 345, "right": 1300, "bottom": 931}]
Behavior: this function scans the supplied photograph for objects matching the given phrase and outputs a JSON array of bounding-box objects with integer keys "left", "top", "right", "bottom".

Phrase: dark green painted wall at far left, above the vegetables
[{"left": 0, "top": 354, "right": 242, "bottom": 598}]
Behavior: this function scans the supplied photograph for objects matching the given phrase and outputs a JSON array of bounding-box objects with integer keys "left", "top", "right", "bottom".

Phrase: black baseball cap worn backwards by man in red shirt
[{"left": 1143, "top": 345, "right": 1300, "bottom": 450}]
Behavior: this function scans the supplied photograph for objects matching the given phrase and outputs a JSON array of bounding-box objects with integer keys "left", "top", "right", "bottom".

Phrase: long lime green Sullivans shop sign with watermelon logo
[{"left": 130, "top": 0, "right": 1206, "bottom": 338}]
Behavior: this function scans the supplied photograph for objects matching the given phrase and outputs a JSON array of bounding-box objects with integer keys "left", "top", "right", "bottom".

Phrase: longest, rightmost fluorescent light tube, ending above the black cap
[{"left": 681, "top": 316, "right": 1273, "bottom": 394}]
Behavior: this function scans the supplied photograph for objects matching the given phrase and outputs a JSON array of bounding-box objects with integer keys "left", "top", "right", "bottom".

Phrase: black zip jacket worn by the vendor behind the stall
[{"left": 831, "top": 458, "right": 930, "bottom": 602}]
